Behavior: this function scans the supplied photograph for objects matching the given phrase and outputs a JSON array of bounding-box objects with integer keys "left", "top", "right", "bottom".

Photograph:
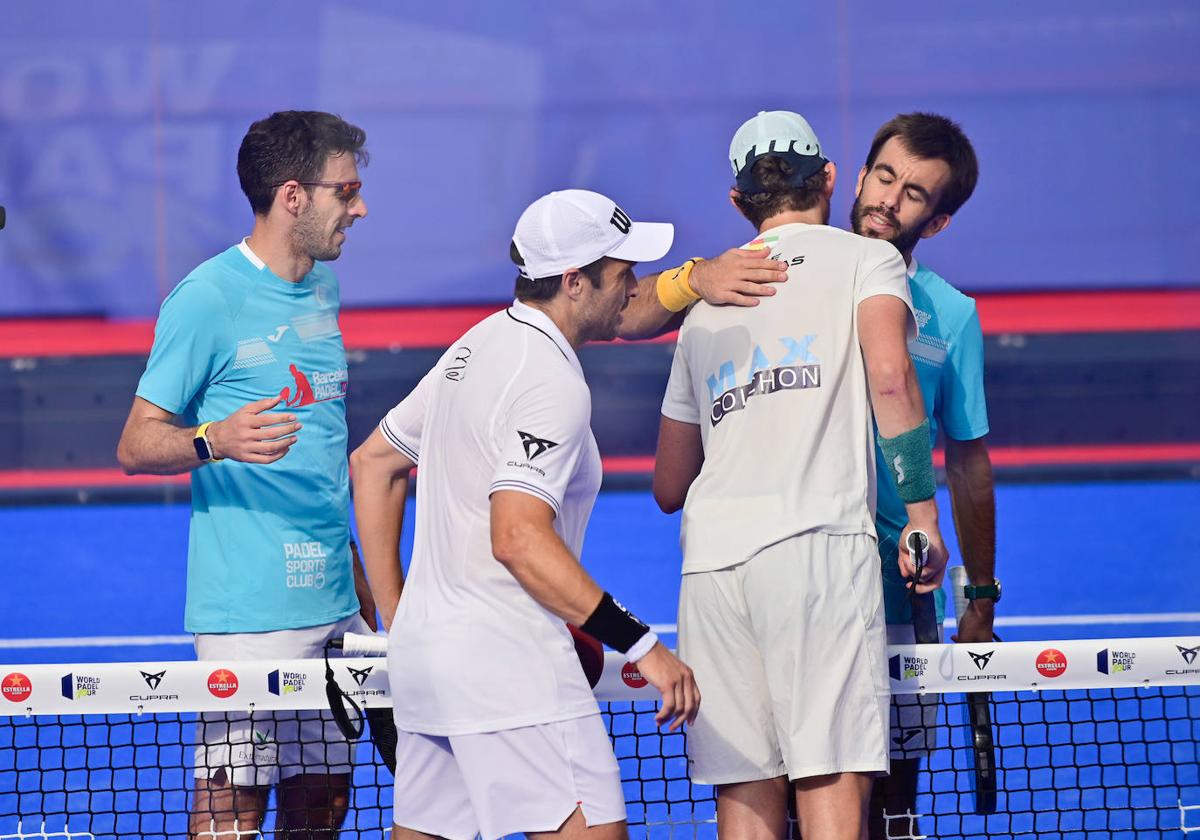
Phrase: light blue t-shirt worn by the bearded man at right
[{"left": 875, "top": 260, "right": 988, "bottom": 624}]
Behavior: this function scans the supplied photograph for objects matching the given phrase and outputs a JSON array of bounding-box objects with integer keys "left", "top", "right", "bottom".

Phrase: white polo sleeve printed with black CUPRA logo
[{"left": 488, "top": 379, "right": 593, "bottom": 516}]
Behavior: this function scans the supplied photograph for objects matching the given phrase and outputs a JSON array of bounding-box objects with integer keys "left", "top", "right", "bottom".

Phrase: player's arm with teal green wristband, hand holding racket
[{"left": 858, "top": 294, "right": 947, "bottom": 593}]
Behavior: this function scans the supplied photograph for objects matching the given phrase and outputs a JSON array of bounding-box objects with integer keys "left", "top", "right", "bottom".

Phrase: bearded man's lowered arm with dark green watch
[{"left": 946, "top": 437, "right": 996, "bottom": 642}]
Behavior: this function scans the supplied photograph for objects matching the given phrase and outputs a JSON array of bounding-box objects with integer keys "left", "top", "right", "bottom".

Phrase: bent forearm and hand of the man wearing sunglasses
[{"left": 116, "top": 396, "right": 300, "bottom": 475}]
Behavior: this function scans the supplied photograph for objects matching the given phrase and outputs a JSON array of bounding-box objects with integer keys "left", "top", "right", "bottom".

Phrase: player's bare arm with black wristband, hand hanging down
[{"left": 491, "top": 490, "right": 700, "bottom": 730}]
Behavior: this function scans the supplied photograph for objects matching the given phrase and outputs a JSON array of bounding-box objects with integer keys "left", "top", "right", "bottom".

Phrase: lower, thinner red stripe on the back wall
[{"left": 0, "top": 443, "right": 1200, "bottom": 490}]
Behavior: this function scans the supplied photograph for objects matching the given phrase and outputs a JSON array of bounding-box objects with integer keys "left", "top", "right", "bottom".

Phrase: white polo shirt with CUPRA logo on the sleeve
[{"left": 379, "top": 302, "right": 601, "bottom": 736}]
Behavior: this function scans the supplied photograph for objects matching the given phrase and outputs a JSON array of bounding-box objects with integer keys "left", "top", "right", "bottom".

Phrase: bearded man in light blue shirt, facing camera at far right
[{"left": 851, "top": 113, "right": 1000, "bottom": 838}]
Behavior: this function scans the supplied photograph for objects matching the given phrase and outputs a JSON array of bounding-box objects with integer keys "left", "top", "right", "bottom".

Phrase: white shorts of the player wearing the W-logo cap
[{"left": 392, "top": 714, "right": 625, "bottom": 840}]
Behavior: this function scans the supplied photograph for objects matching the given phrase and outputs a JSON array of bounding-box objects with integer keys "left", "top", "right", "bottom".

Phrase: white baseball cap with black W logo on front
[{"left": 512, "top": 190, "right": 674, "bottom": 280}]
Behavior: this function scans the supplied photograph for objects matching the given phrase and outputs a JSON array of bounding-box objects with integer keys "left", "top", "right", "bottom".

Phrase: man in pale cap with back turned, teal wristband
[{"left": 654, "top": 112, "right": 946, "bottom": 840}]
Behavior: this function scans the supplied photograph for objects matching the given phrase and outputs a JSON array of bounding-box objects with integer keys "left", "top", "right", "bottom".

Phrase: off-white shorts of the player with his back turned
[{"left": 679, "top": 533, "right": 890, "bottom": 785}]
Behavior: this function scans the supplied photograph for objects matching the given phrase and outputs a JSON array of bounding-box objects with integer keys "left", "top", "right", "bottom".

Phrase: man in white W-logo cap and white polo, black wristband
[{"left": 350, "top": 190, "right": 700, "bottom": 840}]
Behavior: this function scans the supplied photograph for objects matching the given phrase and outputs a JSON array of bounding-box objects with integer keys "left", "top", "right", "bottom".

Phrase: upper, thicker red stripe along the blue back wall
[{"left": 0, "top": 289, "right": 1200, "bottom": 356}]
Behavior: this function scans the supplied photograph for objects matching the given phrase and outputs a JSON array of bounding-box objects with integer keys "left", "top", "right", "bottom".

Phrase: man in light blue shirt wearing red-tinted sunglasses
[{"left": 118, "top": 112, "right": 374, "bottom": 835}]
